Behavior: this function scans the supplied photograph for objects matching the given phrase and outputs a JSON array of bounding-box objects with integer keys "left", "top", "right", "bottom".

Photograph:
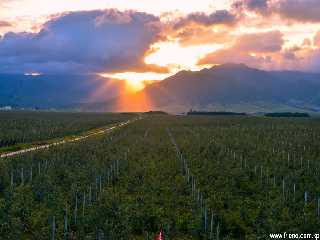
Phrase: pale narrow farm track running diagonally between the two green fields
[{"left": 0, "top": 118, "right": 141, "bottom": 158}]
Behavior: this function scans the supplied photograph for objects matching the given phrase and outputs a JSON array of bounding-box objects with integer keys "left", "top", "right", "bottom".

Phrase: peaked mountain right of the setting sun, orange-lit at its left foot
[{"left": 98, "top": 64, "right": 320, "bottom": 112}]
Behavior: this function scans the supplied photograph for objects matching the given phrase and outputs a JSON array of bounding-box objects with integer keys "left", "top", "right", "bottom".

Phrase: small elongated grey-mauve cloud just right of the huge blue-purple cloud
[{"left": 174, "top": 10, "right": 237, "bottom": 29}]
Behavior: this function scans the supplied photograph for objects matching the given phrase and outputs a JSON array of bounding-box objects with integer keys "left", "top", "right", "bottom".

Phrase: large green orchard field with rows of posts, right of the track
[{"left": 0, "top": 113, "right": 320, "bottom": 240}]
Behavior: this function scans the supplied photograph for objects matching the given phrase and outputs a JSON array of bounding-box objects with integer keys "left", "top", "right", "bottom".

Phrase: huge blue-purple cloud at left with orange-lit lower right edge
[{"left": 0, "top": 9, "right": 166, "bottom": 73}]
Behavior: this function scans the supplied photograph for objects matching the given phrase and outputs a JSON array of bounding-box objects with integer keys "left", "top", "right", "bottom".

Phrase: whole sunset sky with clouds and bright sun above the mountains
[{"left": 0, "top": 0, "right": 320, "bottom": 88}]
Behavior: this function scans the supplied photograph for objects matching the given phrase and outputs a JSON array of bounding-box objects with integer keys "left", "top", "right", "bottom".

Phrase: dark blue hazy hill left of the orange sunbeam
[{"left": 0, "top": 74, "right": 125, "bottom": 108}]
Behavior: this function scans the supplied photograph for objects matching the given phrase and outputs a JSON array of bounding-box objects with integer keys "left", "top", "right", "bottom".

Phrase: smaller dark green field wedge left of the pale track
[{"left": 0, "top": 111, "right": 132, "bottom": 153}]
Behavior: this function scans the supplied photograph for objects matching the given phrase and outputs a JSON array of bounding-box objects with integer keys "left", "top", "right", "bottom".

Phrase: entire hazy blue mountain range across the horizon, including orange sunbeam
[{"left": 0, "top": 64, "right": 320, "bottom": 112}]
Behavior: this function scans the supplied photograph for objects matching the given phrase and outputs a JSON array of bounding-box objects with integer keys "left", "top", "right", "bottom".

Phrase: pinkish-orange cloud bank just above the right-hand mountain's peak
[{"left": 198, "top": 28, "right": 320, "bottom": 72}]
